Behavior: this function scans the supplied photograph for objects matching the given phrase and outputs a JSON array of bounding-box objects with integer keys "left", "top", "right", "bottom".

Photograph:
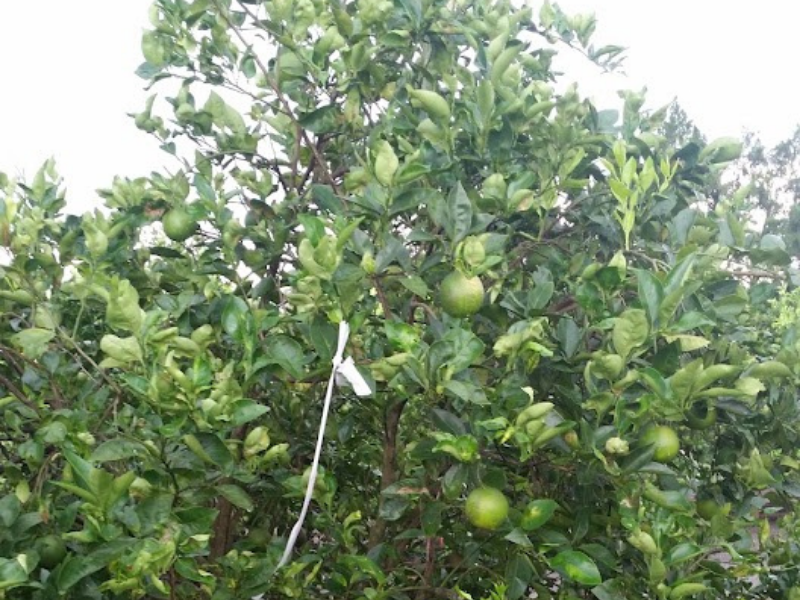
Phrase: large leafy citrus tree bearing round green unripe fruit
[{"left": 0, "top": 0, "right": 800, "bottom": 600}]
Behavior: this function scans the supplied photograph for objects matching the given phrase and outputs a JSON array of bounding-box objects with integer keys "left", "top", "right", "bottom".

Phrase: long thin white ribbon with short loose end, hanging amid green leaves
[{"left": 276, "top": 321, "right": 372, "bottom": 569}]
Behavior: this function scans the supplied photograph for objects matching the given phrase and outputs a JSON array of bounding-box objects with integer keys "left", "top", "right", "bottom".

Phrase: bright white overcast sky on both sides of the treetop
[{"left": 0, "top": 0, "right": 800, "bottom": 211}]
